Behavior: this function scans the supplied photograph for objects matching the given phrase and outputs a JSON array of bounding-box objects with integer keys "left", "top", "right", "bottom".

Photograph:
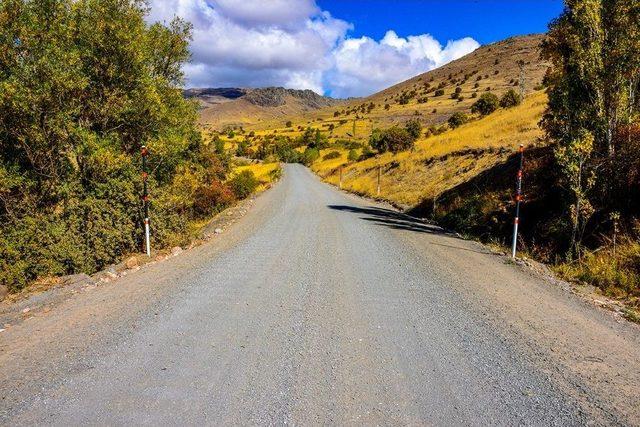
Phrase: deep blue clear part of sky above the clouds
[{"left": 317, "top": 0, "right": 563, "bottom": 44}]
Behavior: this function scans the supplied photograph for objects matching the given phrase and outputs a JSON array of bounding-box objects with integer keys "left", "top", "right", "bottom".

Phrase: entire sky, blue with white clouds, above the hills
[{"left": 148, "top": 0, "right": 562, "bottom": 98}]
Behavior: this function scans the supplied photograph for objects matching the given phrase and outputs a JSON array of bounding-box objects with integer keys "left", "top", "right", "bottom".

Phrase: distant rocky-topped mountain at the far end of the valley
[{"left": 184, "top": 87, "right": 346, "bottom": 129}]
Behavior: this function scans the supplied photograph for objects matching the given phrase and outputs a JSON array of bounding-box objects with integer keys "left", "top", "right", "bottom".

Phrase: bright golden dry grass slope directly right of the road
[{"left": 312, "top": 92, "right": 547, "bottom": 207}]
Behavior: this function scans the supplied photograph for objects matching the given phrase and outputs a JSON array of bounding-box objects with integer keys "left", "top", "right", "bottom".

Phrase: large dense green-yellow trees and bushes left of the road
[{"left": 0, "top": 0, "right": 230, "bottom": 291}]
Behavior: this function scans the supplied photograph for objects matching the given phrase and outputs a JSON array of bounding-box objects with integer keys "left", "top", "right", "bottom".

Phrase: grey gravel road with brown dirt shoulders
[{"left": 0, "top": 165, "right": 640, "bottom": 426}]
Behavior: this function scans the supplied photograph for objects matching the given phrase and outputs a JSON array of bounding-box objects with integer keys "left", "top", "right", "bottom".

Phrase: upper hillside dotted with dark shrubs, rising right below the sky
[{"left": 242, "top": 35, "right": 548, "bottom": 141}]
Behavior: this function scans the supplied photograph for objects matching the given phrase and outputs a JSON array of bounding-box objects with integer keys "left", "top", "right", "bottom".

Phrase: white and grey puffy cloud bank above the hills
[{"left": 148, "top": 0, "right": 479, "bottom": 97}]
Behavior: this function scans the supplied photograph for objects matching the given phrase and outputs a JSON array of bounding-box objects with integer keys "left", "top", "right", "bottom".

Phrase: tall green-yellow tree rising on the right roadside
[{"left": 541, "top": 0, "right": 640, "bottom": 254}]
